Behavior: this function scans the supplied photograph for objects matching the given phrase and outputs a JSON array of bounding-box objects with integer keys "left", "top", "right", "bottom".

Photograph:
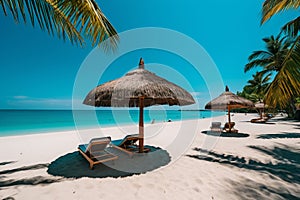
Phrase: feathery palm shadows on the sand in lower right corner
[{"left": 187, "top": 145, "right": 300, "bottom": 199}]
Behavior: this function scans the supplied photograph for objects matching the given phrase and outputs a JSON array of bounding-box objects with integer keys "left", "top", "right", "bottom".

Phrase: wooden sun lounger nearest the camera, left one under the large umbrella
[{"left": 78, "top": 137, "right": 118, "bottom": 169}]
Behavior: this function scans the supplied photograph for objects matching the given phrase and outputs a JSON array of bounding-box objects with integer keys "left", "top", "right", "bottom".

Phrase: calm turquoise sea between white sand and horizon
[{"left": 0, "top": 109, "right": 224, "bottom": 136}]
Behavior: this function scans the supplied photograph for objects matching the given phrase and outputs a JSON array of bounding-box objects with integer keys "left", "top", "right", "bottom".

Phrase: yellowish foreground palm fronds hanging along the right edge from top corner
[{"left": 261, "top": 0, "right": 300, "bottom": 115}]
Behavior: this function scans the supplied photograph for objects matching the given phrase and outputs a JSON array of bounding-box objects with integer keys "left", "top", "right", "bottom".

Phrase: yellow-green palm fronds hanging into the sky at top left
[{"left": 0, "top": 0, "right": 118, "bottom": 49}]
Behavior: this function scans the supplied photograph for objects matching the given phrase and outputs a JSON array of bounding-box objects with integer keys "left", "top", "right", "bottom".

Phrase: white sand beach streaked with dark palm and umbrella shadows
[{"left": 0, "top": 114, "right": 300, "bottom": 200}]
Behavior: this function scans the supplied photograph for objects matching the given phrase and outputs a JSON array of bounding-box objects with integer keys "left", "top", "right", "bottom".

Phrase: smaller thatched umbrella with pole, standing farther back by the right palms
[{"left": 205, "top": 86, "right": 254, "bottom": 132}]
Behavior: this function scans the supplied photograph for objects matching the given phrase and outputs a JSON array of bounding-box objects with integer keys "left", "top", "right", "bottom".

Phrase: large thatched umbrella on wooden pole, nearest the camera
[{"left": 83, "top": 58, "right": 195, "bottom": 152}]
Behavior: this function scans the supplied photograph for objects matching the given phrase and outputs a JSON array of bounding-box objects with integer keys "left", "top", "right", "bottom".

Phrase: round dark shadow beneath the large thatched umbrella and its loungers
[{"left": 47, "top": 146, "right": 171, "bottom": 178}]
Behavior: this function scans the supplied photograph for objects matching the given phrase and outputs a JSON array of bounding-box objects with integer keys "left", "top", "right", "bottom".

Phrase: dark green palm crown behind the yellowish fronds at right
[{"left": 244, "top": 34, "right": 292, "bottom": 73}]
